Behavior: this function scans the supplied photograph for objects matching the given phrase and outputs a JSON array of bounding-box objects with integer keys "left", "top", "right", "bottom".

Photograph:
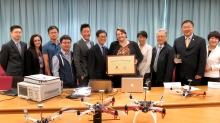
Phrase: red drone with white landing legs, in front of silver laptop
[{"left": 125, "top": 88, "right": 166, "bottom": 123}]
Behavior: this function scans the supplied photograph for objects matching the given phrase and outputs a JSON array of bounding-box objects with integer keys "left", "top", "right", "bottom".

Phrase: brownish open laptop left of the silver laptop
[{"left": 89, "top": 79, "right": 112, "bottom": 93}]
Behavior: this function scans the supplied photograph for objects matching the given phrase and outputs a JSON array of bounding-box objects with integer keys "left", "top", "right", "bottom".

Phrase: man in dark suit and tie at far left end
[{"left": 0, "top": 25, "right": 27, "bottom": 76}]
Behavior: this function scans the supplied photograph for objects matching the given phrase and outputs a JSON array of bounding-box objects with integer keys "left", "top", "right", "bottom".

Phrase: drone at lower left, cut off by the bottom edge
[{"left": 24, "top": 104, "right": 75, "bottom": 123}]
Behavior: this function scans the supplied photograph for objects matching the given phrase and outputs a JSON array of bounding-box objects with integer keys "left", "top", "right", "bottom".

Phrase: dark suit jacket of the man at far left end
[{"left": 0, "top": 40, "right": 27, "bottom": 76}]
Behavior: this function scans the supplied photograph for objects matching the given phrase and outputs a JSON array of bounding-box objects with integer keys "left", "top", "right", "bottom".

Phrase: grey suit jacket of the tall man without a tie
[{"left": 73, "top": 39, "right": 94, "bottom": 77}]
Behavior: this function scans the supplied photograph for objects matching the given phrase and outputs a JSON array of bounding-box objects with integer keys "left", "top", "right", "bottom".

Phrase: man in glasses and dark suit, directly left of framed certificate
[{"left": 88, "top": 30, "right": 108, "bottom": 79}]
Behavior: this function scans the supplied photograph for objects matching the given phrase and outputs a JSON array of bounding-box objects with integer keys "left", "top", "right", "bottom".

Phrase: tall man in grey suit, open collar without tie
[{"left": 73, "top": 24, "right": 94, "bottom": 87}]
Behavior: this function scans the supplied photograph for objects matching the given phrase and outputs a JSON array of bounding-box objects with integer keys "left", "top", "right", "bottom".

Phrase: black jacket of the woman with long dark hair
[{"left": 25, "top": 49, "right": 44, "bottom": 75}]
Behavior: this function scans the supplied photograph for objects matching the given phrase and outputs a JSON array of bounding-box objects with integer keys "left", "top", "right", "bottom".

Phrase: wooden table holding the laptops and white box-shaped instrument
[{"left": 0, "top": 86, "right": 220, "bottom": 114}]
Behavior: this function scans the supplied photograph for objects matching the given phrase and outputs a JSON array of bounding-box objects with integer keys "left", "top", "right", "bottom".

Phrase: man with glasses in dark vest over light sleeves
[{"left": 52, "top": 35, "right": 76, "bottom": 88}]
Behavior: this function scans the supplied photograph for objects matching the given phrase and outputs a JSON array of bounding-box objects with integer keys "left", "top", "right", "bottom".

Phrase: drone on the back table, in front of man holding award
[{"left": 170, "top": 79, "right": 206, "bottom": 98}]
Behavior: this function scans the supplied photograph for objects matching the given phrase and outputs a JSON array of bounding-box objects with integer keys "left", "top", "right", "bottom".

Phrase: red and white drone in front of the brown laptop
[{"left": 77, "top": 90, "right": 126, "bottom": 120}]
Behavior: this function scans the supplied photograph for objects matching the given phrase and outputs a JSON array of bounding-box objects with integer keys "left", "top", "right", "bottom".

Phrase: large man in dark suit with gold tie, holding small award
[{"left": 173, "top": 20, "right": 206, "bottom": 85}]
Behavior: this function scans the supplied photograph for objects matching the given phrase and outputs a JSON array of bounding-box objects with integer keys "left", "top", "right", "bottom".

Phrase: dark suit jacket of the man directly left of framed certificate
[{"left": 88, "top": 44, "right": 108, "bottom": 79}]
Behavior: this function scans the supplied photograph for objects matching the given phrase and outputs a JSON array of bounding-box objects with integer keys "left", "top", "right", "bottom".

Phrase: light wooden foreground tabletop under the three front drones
[{"left": 0, "top": 107, "right": 220, "bottom": 123}]
